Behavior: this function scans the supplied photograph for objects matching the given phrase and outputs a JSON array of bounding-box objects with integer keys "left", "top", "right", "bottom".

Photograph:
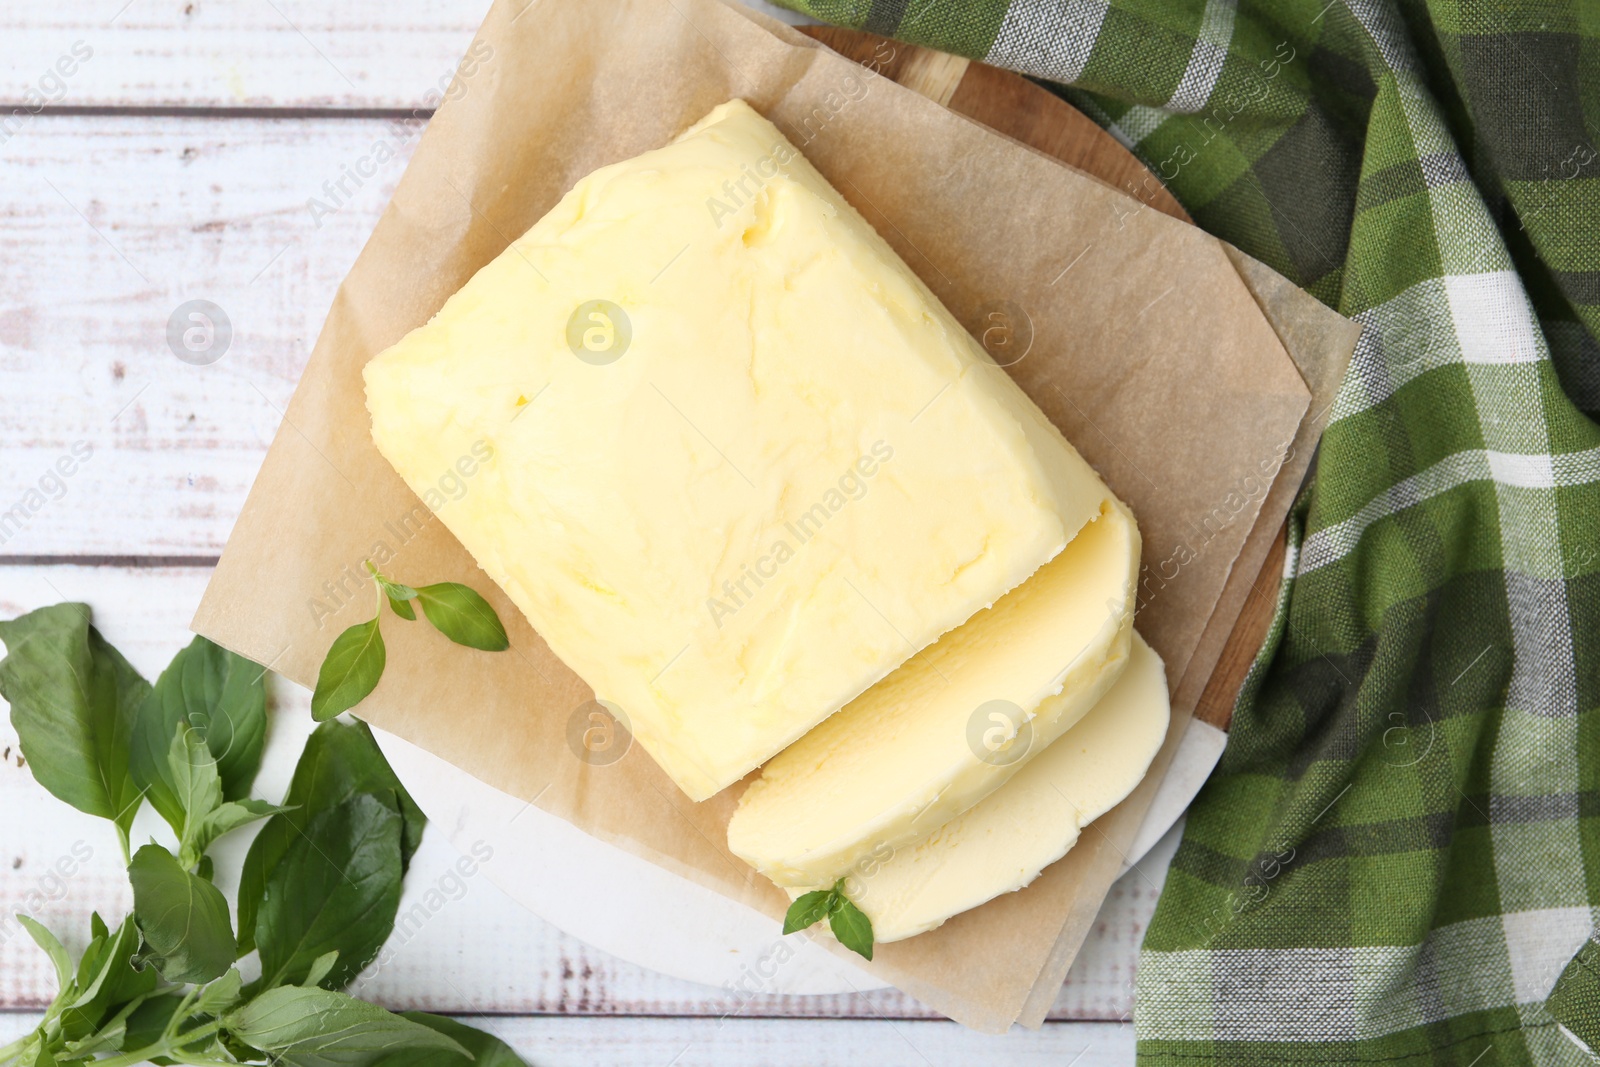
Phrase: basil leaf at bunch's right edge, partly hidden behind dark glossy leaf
[{"left": 238, "top": 720, "right": 427, "bottom": 952}]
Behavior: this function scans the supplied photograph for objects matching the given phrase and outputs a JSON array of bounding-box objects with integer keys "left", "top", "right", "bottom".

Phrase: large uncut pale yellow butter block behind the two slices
[{"left": 365, "top": 101, "right": 1110, "bottom": 800}]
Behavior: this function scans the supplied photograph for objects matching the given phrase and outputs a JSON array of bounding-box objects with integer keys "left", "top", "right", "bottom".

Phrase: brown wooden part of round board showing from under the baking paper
[{"left": 798, "top": 26, "right": 1285, "bottom": 729}]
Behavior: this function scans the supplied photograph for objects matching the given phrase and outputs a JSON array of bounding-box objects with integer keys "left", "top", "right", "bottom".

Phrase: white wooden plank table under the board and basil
[{"left": 0, "top": 0, "right": 1176, "bottom": 1067}]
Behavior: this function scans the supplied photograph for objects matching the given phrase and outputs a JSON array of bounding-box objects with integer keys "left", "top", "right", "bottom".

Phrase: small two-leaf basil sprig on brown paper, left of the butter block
[{"left": 310, "top": 560, "right": 510, "bottom": 721}]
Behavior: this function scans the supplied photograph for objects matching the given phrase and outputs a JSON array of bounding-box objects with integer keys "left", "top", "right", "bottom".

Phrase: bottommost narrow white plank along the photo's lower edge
[{"left": 0, "top": 1013, "right": 1134, "bottom": 1067}]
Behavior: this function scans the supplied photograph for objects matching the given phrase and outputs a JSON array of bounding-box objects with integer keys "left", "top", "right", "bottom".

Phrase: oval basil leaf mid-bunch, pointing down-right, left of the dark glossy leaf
[{"left": 128, "top": 845, "right": 237, "bottom": 984}]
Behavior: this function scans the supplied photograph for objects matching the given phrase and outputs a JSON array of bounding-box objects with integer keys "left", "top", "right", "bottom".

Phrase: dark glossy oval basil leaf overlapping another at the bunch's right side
[{"left": 256, "top": 793, "right": 402, "bottom": 989}]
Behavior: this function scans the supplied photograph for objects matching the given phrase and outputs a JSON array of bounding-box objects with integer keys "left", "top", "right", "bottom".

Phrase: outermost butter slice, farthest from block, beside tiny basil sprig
[{"left": 806, "top": 633, "right": 1171, "bottom": 942}]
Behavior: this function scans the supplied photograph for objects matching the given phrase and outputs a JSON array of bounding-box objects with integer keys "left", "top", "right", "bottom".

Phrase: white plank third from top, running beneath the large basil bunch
[{"left": 0, "top": 566, "right": 1165, "bottom": 1023}]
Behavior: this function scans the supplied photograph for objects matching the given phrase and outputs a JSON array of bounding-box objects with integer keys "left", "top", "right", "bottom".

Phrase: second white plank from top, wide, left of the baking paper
[{"left": 0, "top": 117, "right": 421, "bottom": 557}]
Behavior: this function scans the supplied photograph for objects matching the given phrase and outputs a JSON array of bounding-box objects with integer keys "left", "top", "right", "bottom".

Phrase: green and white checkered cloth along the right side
[{"left": 774, "top": 0, "right": 1600, "bottom": 1067}]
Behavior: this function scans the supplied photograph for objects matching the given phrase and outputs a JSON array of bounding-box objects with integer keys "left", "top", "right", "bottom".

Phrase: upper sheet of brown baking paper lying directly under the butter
[{"left": 184, "top": 0, "right": 1337, "bottom": 1030}]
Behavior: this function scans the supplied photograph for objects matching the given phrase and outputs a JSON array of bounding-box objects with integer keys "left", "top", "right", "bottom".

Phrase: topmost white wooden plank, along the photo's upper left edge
[{"left": 0, "top": 0, "right": 800, "bottom": 111}]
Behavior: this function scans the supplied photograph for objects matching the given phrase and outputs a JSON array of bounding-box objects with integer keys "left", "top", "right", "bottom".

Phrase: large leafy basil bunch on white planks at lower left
[{"left": 0, "top": 604, "right": 525, "bottom": 1067}]
